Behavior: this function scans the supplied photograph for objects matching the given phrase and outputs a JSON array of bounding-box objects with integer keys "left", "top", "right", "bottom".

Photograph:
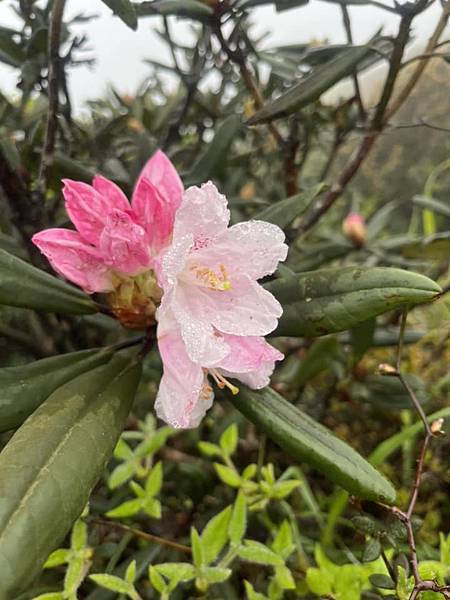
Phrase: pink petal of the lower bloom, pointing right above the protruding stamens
[{"left": 218, "top": 333, "right": 284, "bottom": 373}]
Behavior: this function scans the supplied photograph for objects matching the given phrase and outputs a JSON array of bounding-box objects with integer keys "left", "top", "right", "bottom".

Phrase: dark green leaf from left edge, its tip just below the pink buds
[{"left": 0, "top": 250, "right": 98, "bottom": 315}]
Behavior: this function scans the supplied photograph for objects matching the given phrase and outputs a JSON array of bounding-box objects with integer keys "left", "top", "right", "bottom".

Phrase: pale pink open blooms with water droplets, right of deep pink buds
[{"left": 156, "top": 183, "right": 287, "bottom": 427}]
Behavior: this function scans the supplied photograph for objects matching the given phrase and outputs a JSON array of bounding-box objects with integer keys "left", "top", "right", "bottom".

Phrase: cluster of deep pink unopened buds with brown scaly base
[{"left": 33, "top": 151, "right": 184, "bottom": 328}]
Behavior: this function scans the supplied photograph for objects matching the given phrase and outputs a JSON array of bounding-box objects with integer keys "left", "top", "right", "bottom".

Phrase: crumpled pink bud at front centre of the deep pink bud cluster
[{"left": 100, "top": 209, "right": 150, "bottom": 275}]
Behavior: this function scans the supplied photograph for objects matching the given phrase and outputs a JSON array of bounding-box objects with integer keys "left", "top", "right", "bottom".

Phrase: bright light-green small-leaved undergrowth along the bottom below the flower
[{"left": 34, "top": 418, "right": 450, "bottom": 600}]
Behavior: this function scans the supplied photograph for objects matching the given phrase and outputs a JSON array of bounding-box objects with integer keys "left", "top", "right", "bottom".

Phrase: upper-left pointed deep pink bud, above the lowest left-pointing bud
[{"left": 63, "top": 179, "right": 116, "bottom": 246}]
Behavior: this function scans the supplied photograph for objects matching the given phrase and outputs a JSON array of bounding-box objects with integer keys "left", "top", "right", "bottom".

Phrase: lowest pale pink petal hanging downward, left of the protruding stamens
[{"left": 155, "top": 323, "right": 214, "bottom": 429}]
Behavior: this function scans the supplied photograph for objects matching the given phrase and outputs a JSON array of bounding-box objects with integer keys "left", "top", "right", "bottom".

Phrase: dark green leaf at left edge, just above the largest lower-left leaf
[{"left": 0, "top": 348, "right": 112, "bottom": 432}]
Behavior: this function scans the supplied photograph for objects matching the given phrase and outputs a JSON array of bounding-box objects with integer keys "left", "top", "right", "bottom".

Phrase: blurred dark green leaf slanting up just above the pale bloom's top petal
[{"left": 184, "top": 115, "right": 241, "bottom": 186}]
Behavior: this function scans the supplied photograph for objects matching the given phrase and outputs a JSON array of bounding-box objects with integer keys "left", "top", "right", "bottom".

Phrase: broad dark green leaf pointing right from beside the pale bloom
[{"left": 266, "top": 267, "right": 442, "bottom": 337}]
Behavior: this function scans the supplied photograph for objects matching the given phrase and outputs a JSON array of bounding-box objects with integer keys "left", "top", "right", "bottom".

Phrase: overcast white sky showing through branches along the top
[{"left": 0, "top": 0, "right": 440, "bottom": 110}]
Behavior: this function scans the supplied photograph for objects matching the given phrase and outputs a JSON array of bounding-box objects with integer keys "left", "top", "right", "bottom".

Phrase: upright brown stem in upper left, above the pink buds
[{"left": 38, "top": 0, "right": 66, "bottom": 194}]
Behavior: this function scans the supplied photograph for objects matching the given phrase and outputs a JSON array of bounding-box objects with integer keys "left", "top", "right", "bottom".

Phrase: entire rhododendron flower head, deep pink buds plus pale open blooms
[{"left": 33, "top": 151, "right": 287, "bottom": 428}]
